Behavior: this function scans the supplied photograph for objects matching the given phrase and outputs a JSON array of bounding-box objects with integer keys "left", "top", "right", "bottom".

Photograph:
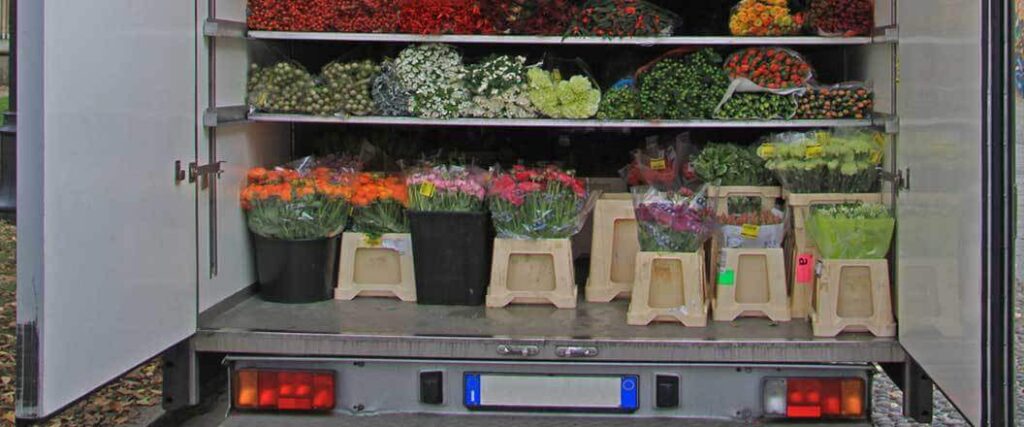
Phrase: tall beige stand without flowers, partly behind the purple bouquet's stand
[{"left": 587, "top": 193, "right": 640, "bottom": 302}]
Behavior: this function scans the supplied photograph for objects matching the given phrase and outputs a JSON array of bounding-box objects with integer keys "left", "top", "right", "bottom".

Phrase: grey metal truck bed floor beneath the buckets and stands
[{"left": 195, "top": 297, "right": 905, "bottom": 364}]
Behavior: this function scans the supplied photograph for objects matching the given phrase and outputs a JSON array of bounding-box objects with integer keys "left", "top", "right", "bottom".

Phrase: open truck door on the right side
[{"left": 897, "top": 0, "right": 1013, "bottom": 425}]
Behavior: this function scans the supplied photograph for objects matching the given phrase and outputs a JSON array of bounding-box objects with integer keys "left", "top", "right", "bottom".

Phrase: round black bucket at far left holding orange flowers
[{"left": 253, "top": 236, "right": 341, "bottom": 304}]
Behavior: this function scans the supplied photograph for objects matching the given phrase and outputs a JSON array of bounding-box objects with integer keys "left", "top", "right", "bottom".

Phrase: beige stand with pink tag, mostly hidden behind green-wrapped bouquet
[{"left": 782, "top": 191, "right": 882, "bottom": 318}]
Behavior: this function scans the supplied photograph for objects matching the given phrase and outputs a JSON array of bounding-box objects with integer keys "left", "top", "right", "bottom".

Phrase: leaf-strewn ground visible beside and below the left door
[{"left": 0, "top": 223, "right": 162, "bottom": 427}]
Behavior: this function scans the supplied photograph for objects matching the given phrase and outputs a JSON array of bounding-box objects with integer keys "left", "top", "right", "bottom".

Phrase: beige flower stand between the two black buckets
[{"left": 334, "top": 232, "right": 416, "bottom": 302}]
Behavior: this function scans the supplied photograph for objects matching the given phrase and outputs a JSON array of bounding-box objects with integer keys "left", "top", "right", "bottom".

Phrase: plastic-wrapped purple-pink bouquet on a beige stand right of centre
[{"left": 633, "top": 187, "right": 715, "bottom": 253}]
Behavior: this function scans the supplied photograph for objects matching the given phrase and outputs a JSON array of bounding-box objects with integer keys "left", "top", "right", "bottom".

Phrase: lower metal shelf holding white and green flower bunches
[{"left": 249, "top": 113, "right": 878, "bottom": 129}]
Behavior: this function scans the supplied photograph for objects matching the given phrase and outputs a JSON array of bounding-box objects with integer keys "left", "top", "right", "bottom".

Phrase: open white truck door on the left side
[{"left": 16, "top": 0, "right": 198, "bottom": 419}]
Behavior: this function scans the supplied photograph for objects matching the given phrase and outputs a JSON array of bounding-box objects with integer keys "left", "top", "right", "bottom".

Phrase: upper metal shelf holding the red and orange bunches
[{"left": 248, "top": 31, "right": 891, "bottom": 46}]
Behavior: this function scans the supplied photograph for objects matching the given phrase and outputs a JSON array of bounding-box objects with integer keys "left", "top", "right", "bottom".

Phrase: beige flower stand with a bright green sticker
[{"left": 712, "top": 248, "right": 791, "bottom": 322}]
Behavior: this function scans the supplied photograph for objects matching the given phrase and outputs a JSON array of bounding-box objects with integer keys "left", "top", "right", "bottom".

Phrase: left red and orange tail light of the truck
[{"left": 233, "top": 370, "right": 335, "bottom": 411}]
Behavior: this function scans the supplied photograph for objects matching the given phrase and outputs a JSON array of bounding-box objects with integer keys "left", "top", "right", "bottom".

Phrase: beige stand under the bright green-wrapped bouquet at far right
[{"left": 811, "top": 259, "right": 896, "bottom": 337}]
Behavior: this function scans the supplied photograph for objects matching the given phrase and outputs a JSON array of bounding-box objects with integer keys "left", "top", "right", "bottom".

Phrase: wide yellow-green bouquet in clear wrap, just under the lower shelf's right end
[{"left": 758, "top": 131, "right": 885, "bottom": 194}]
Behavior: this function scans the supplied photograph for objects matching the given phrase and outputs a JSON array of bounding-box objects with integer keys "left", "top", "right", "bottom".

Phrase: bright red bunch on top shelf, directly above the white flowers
[{"left": 398, "top": 0, "right": 497, "bottom": 34}]
